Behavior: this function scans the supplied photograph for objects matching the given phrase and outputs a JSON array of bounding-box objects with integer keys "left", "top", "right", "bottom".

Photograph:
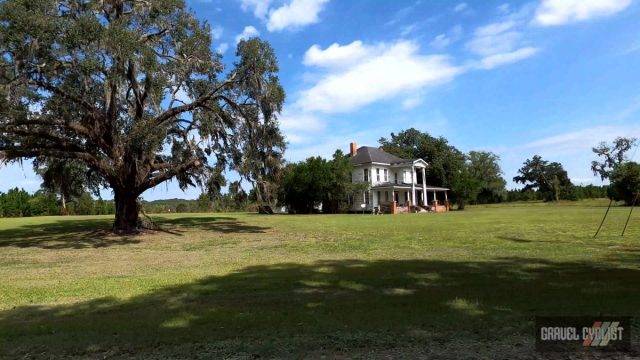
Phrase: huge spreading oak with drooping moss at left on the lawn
[{"left": 0, "top": 0, "right": 284, "bottom": 232}]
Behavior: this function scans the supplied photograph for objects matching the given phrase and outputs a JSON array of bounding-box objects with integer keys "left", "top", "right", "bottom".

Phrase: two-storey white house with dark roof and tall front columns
[{"left": 349, "top": 143, "right": 449, "bottom": 213}]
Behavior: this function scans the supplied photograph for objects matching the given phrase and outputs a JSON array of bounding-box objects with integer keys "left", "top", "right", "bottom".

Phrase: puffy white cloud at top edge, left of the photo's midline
[{"left": 267, "top": 0, "right": 329, "bottom": 31}]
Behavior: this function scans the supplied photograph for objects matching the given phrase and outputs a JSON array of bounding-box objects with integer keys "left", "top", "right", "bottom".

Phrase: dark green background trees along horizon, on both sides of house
[{"left": 0, "top": 128, "right": 640, "bottom": 217}]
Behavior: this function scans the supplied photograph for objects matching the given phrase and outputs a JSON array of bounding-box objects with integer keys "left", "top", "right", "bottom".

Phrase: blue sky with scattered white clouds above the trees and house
[{"left": 0, "top": 0, "right": 640, "bottom": 200}]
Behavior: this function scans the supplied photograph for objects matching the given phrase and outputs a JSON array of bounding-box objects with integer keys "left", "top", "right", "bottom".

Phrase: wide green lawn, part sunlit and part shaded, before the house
[{"left": 0, "top": 201, "right": 640, "bottom": 359}]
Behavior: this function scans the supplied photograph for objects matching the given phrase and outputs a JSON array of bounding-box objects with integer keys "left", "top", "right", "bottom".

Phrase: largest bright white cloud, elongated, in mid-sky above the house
[{"left": 296, "top": 40, "right": 464, "bottom": 113}]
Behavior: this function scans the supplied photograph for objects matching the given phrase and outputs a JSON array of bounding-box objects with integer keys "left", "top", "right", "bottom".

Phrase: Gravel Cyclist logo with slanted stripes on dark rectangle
[{"left": 536, "top": 316, "right": 631, "bottom": 351}]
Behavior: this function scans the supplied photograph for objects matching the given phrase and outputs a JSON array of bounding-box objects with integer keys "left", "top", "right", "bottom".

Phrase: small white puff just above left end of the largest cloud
[{"left": 303, "top": 40, "right": 372, "bottom": 67}]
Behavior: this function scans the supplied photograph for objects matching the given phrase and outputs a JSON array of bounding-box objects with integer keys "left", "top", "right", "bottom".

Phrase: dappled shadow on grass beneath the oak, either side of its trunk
[{"left": 0, "top": 216, "right": 268, "bottom": 250}]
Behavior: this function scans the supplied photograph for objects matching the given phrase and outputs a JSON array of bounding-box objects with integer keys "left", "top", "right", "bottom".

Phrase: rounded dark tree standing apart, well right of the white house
[{"left": 513, "top": 155, "right": 573, "bottom": 201}]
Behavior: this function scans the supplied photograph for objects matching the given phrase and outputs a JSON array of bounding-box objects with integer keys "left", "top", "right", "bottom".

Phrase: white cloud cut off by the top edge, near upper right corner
[{"left": 534, "top": 0, "right": 631, "bottom": 26}]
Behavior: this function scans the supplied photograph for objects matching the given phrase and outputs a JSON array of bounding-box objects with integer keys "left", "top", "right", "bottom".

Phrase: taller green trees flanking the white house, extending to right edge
[{"left": 279, "top": 128, "right": 640, "bottom": 213}]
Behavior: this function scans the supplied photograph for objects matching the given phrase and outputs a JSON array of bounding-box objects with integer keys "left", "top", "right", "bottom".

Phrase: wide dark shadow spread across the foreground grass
[{"left": 0, "top": 255, "right": 640, "bottom": 358}]
